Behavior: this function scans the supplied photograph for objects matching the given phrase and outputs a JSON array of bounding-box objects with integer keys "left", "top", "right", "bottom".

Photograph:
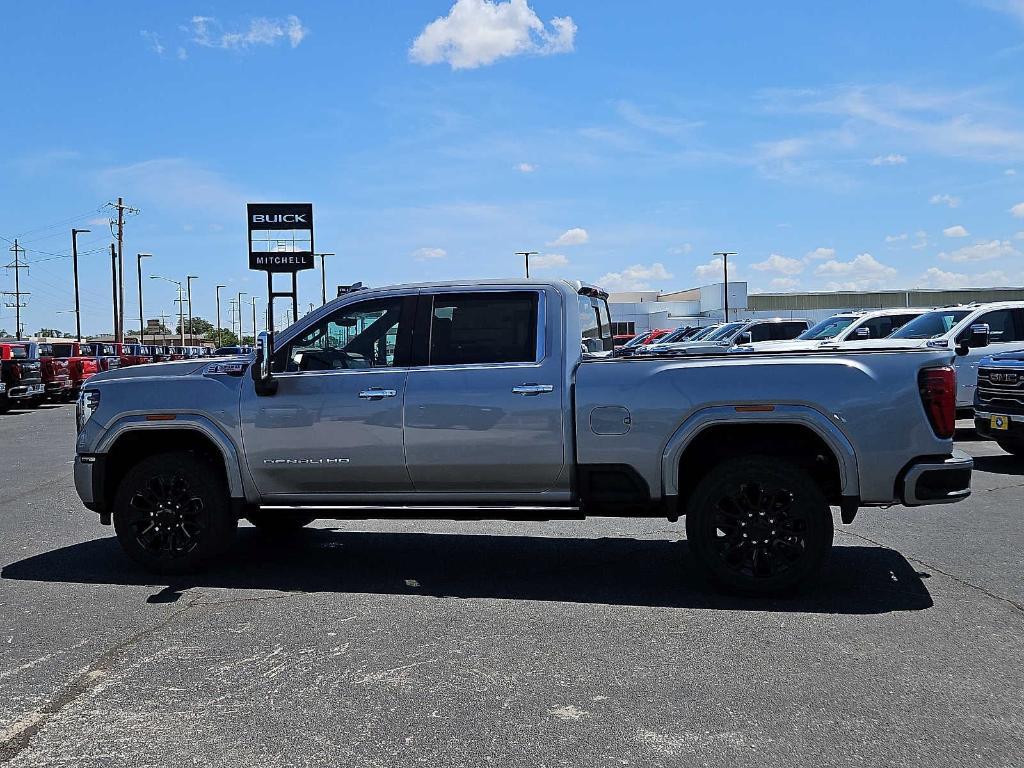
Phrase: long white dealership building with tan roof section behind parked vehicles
[{"left": 608, "top": 281, "right": 1024, "bottom": 334}]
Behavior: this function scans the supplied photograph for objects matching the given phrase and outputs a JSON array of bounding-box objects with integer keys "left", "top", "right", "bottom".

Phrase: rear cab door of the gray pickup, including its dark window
[{"left": 406, "top": 289, "right": 567, "bottom": 493}]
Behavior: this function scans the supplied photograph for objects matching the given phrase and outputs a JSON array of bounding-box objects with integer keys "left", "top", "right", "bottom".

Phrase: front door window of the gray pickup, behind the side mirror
[{"left": 274, "top": 297, "right": 408, "bottom": 371}]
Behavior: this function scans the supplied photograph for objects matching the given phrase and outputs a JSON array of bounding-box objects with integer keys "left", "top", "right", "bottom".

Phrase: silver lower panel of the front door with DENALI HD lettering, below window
[{"left": 242, "top": 369, "right": 413, "bottom": 496}]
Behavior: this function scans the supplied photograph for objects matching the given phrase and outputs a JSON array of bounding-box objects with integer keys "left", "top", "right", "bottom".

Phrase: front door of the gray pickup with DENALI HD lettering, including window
[{"left": 241, "top": 295, "right": 416, "bottom": 503}]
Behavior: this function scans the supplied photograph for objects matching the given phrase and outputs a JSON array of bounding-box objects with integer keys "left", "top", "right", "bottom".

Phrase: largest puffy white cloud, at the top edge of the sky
[{"left": 409, "top": 0, "right": 577, "bottom": 70}]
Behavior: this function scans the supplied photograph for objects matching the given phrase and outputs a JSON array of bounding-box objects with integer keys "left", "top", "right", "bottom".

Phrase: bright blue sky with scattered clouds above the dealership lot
[{"left": 0, "top": 0, "right": 1024, "bottom": 332}]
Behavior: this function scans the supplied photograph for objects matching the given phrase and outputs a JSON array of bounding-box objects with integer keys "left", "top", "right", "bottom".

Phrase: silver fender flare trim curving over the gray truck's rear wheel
[{"left": 662, "top": 406, "right": 860, "bottom": 497}]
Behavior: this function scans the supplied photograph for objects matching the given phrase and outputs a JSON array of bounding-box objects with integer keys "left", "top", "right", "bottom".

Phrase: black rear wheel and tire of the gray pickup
[{"left": 686, "top": 456, "right": 834, "bottom": 597}]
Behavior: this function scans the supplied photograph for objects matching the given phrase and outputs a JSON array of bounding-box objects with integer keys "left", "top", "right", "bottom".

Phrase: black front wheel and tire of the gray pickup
[{"left": 113, "top": 452, "right": 239, "bottom": 573}]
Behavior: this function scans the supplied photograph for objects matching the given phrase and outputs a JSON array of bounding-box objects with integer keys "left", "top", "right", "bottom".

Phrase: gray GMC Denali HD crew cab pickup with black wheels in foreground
[{"left": 75, "top": 281, "right": 972, "bottom": 594}]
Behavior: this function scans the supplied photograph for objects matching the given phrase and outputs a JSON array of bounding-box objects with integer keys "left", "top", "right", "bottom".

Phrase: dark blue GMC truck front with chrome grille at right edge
[{"left": 974, "top": 350, "right": 1024, "bottom": 456}]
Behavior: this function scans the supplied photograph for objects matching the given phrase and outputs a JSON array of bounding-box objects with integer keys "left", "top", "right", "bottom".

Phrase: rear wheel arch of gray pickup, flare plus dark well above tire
[{"left": 662, "top": 406, "right": 860, "bottom": 509}]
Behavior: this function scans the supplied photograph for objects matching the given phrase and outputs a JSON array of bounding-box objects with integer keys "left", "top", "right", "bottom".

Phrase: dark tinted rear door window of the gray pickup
[{"left": 428, "top": 292, "right": 538, "bottom": 366}]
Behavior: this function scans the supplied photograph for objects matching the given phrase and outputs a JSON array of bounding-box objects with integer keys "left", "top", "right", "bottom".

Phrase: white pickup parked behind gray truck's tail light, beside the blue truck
[{"left": 857, "top": 301, "right": 1024, "bottom": 418}]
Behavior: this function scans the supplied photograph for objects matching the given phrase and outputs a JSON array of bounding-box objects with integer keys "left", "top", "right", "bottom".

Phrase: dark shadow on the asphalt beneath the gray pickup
[{"left": 0, "top": 528, "right": 933, "bottom": 614}]
